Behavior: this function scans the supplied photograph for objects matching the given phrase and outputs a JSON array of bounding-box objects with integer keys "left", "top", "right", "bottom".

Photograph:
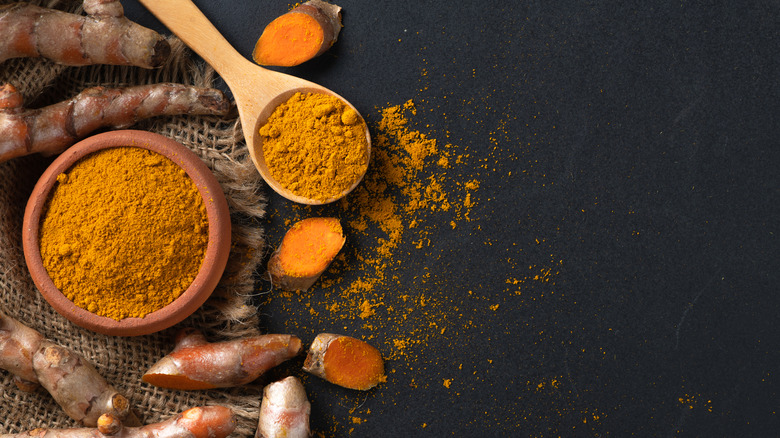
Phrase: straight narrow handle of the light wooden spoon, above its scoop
[{"left": 139, "top": 0, "right": 249, "bottom": 82}]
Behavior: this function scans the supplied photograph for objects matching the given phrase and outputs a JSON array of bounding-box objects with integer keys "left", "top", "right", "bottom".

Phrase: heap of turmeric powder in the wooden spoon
[{"left": 259, "top": 92, "right": 368, "bottom": 202}]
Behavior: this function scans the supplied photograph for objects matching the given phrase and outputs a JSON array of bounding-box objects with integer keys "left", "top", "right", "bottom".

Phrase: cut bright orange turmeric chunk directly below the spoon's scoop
[{"left": 268, "top": 217, "right": 346, "bottom": 290}]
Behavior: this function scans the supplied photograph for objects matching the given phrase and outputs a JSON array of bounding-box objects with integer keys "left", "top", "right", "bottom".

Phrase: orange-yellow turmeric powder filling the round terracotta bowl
[{"left": 38, "top": 147, "right": 208, "bottom": 321}]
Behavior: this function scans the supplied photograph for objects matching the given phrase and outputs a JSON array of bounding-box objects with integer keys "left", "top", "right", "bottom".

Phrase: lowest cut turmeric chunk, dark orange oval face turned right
[{"left": 303, "top": 333, "right": 386, "bottom": 390}]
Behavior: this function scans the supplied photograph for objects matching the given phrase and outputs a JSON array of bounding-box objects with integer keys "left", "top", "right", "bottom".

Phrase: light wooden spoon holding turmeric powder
[{"left": 140, "top": 0, "right": 371, "bottom": 205}]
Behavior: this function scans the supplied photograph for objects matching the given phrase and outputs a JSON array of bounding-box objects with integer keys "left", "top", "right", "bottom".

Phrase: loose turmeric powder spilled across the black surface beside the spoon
[{"left": 267, "top": 96, "right": 560, "bottom": 436}]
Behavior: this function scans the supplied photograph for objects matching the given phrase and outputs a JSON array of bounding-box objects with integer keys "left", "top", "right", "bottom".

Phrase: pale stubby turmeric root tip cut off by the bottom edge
[{"left": 255, "top": 376, "right": 311, "bottom": 438}]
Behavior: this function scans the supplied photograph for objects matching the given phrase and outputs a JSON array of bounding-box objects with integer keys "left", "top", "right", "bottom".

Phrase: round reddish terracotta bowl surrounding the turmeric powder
[{"left": 22, "top": 130, "right": 230, "bottom": 336}]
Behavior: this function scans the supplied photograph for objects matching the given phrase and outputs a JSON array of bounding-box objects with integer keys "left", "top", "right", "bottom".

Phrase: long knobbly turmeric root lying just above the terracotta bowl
[{"left": 0, "top": 83, "right": 230, "bottom": 162}]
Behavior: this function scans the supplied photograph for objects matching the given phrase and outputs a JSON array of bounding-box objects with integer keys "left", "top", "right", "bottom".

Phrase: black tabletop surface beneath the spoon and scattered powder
[{"left": 123, "top": 0, "right": 780, "bottom": 437}]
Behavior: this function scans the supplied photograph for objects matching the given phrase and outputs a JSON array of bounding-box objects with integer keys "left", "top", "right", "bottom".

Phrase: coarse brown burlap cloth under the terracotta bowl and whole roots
[{"left": 0, "top": 0, "right": 265, "bottom": 436}]
